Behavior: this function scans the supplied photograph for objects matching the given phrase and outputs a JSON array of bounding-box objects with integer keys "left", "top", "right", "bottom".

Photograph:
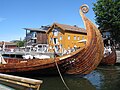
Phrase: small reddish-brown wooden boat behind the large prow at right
[{"left": 100, "top": 47, "right": 117, "bottom": 65}]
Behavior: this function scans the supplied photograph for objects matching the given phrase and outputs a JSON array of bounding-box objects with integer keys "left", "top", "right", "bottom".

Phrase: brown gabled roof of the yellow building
[{"left": 47, "top": 23, "right": 87, "bottom": 34}]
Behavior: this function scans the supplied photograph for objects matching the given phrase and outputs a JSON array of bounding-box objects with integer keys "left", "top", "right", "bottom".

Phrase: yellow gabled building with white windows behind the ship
[{"left": 47, "top": 23, "right": 87, "bottom": 53}]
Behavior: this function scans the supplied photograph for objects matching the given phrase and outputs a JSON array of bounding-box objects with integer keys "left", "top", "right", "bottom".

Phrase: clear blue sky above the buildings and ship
[{"left": 0, "top": 0, "right": 96, "bottom": 41}]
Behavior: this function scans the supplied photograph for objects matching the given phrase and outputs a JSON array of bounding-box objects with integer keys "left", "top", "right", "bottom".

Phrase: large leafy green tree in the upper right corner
[{"left": 93, "top": 0, "right": 120, "bottom": 42}]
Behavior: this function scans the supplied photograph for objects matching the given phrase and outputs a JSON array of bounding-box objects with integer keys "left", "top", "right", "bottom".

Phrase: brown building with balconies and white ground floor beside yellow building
[{"left": 22, "top": 26, "right": 50, "bottom": 52}]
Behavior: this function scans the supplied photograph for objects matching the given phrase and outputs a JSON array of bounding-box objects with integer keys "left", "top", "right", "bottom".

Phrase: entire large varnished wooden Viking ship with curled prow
[{"left": 0, "top": 5, "right": 104, "bottom": 76}]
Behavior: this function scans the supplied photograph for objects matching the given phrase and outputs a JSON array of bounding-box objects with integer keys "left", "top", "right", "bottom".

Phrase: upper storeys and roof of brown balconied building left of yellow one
[{"left": 24, "top": 26, "right": 49, "bottom": 46}]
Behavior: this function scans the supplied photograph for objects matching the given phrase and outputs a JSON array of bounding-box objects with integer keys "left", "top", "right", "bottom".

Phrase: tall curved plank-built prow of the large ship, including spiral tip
[{"left": 67, "top": 4, "right": 104, "bottom": 74}]
